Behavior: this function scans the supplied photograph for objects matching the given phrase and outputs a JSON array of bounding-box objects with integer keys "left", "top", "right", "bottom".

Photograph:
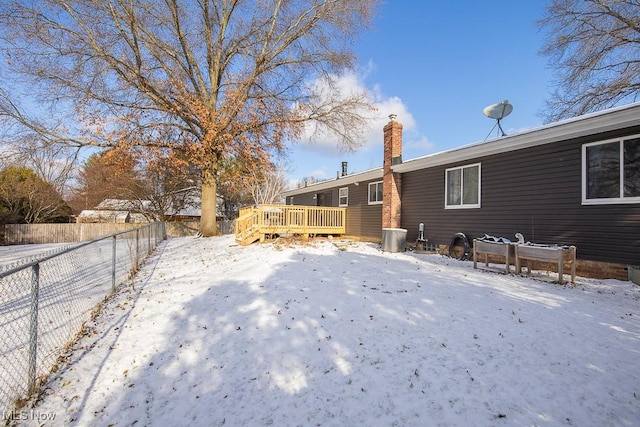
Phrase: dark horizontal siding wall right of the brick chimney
[{"left": 402, "top": 128, "right": 640, "bottom": 264}]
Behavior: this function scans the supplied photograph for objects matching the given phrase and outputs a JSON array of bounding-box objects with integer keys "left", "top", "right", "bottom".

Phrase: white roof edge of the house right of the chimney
[{"left": 392, "top": 102, "right": 640, "bottom": 173}]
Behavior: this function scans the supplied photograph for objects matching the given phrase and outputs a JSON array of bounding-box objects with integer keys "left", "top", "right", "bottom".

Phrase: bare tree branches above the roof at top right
[{"left": 538, "top": 0, "right": 640, "bottom": 121}]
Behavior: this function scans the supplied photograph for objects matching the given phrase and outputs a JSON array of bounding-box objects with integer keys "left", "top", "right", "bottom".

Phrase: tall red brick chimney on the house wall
[{"left": 382, "top": 114, "right": 402, "bottom": 228}]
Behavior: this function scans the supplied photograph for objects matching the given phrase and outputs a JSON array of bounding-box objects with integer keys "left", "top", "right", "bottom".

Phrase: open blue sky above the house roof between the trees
[{"left": 288, "top": 0, "right": 553, "bottom": 187}]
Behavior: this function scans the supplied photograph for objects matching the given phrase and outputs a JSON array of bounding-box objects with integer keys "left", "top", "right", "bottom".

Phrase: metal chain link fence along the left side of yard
[{"left": 0, "top": 223, "right": 166, "bottom": 418}]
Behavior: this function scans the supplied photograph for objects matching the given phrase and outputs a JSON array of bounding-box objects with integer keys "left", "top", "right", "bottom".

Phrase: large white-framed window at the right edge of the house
[{"left": 582, "top": 135, "right": 640, "bottom": 204}]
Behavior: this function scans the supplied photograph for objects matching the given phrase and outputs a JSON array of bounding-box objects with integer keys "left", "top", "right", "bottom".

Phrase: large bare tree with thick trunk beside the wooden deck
[{"left": 0, "top": 0, "right": 378, "bottom": 236}]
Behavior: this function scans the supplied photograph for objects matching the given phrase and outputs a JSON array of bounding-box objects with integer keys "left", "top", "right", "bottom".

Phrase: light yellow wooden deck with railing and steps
[{"left": 235, "top": 205, "right": 346, "bottom": 246}]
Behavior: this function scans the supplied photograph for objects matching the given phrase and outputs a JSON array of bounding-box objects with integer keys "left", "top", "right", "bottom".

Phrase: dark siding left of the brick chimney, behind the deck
[{"left": 287, "top": 180, "right": 382, "bottom": 240}]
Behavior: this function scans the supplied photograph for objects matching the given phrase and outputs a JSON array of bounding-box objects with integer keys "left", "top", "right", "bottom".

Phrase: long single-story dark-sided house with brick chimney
[{"left": 283, "top": 103, "right": 640, "bottom": 279}]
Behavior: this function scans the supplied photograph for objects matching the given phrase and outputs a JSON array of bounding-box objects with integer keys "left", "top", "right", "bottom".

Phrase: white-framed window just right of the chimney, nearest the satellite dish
[{"left": 444, "top": 163, "right": 480, "bottom": 209}]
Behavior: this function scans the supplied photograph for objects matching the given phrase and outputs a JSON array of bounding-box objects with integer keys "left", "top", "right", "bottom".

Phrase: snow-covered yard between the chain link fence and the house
[{"left": 16, "top": 236, "right": 640, "bottom": 426}]
